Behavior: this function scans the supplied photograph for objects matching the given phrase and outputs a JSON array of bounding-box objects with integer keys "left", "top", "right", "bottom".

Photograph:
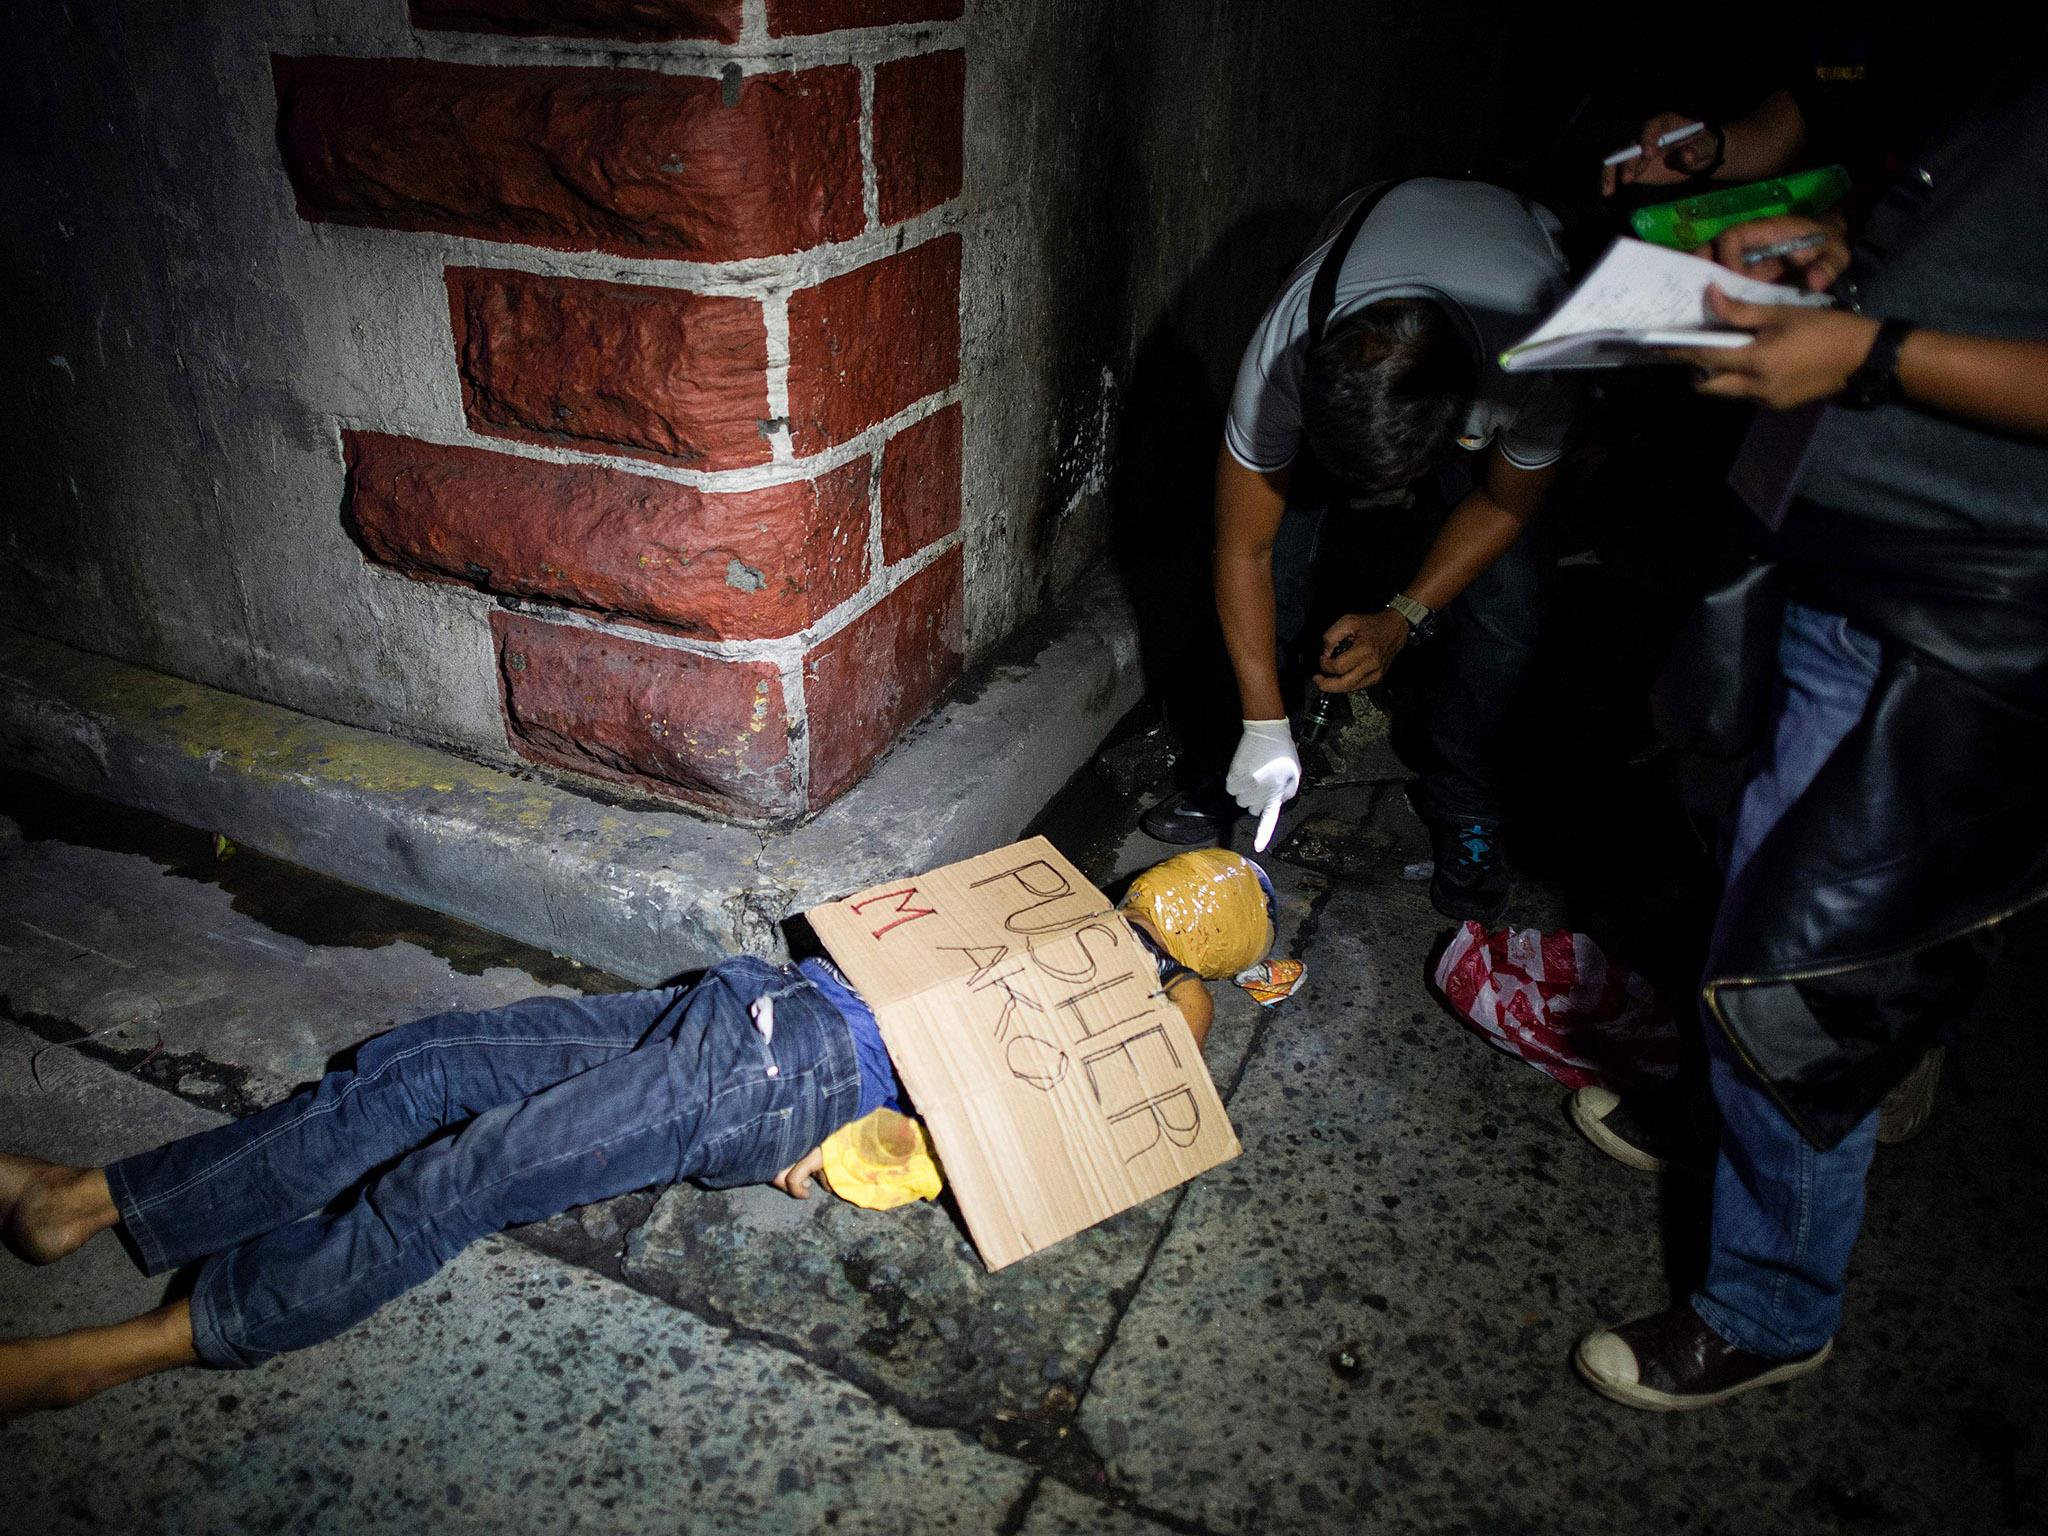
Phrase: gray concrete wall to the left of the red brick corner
[{"left": 0, "top": 0, "right": 520, "bottom": 756}]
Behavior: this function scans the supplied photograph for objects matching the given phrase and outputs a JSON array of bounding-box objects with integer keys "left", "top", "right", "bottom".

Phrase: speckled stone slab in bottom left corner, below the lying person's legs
[{"left": 0, "top": 1239, "right": 1032, "bottom": 1536}]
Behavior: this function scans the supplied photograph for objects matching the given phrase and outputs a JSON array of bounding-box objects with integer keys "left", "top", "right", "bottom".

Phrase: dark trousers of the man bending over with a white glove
[{"left": 1274, "top": 451, "right": 1540, "bottom": 823}]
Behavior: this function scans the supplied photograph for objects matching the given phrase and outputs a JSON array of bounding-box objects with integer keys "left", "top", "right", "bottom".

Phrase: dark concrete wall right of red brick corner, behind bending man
[{"left": 963, "top": 0, "right": 1499, "bottom": 645}]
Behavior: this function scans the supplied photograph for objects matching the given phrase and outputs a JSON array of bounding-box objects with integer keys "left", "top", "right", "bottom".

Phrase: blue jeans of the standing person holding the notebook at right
[{"left": 1692, "top": 604, "right": 1882, "bottom": 1360}]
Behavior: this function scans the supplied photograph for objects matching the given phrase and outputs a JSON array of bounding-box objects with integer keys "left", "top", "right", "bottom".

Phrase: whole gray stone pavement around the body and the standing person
[{"left": 0, "top": 780, "right": 2048, "bottom": 1534}]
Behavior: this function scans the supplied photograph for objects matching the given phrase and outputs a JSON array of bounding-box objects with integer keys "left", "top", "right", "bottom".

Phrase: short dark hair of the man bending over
[{"left": 1300, "top": 299, "right": 1475, "bottom": 492}]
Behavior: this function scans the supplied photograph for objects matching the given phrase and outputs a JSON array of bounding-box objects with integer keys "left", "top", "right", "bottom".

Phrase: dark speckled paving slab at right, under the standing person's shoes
[{"left": 1081, "top": 872, "right": 2048, "bottom": 1532}]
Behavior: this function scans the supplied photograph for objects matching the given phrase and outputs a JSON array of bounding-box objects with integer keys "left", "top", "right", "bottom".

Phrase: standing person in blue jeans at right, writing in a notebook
[{"left": 1577, "top": 66, "right": 2048, "bottom": 1409}]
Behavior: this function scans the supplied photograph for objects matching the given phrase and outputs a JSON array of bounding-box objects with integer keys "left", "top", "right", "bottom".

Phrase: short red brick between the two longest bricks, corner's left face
[{"left": 449, "top": 266, "right": 772, "bottom": 469}]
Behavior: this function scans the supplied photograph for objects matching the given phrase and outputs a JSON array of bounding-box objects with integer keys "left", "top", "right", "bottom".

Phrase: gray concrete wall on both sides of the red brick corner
[{"left": 0, "top": 0, "right": 1495, "bottom": 760}]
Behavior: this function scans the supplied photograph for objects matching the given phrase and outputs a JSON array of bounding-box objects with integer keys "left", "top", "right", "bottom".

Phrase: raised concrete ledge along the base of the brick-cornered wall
[{"left": 0, "top": 565, "right": 1143, "bottom": 985}]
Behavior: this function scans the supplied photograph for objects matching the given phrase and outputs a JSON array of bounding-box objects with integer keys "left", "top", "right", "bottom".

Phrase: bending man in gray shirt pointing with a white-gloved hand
[{"left": 1145, "top": 178, "right": 1573, "bottom": 920}]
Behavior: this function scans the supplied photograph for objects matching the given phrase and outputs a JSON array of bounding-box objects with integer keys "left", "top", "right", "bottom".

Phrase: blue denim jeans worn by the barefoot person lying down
[{"left": 106, "top": 958, "right": 860, "bottom": 1366}]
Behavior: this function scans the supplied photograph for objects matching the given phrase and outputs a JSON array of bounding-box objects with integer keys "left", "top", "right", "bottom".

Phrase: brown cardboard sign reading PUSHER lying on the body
[{"left": 807, "top": 838, "right": 1239, "bottom": 1270}]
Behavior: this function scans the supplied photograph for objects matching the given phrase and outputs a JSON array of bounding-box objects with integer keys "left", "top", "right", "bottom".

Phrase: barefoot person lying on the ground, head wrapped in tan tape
[{"left": 0, "top": 854, "right": 1274, "bottom": 1419}]
